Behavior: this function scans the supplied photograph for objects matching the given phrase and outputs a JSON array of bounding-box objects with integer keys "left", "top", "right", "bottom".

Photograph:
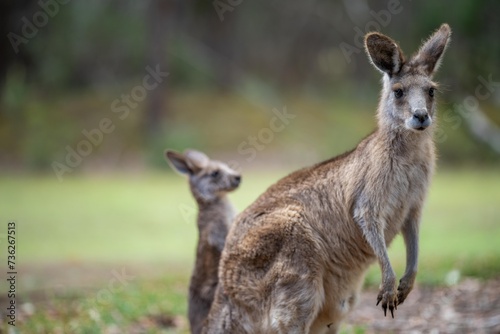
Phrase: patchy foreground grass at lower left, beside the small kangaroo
[{"left": 16, "top": 274, "right": 189, "bottom": 333}]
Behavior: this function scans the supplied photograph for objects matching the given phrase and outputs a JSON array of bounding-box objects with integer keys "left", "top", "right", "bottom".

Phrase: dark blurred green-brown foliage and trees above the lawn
[{"left": 0, "top": 0, "right": 500, "bottom": 171}]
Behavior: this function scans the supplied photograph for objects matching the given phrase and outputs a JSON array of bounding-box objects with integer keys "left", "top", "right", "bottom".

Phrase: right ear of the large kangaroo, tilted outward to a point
[{"left": 412, "top": 23, "right": 451, "bottom": 76}]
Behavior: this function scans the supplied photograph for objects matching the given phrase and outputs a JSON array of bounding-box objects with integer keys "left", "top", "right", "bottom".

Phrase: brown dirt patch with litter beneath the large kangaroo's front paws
[{"left": 343, "top": 279, "right": 500, "bottom": 334}]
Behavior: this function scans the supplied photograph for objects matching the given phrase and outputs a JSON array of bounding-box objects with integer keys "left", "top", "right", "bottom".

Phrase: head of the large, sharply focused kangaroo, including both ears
[{"left": 365, "top": 24, "right": 451, "bottom": 132}]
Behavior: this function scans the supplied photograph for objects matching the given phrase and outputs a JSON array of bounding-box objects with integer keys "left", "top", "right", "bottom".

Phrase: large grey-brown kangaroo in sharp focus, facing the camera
[{"left": 204, "top": 24, "right": 451, "bottom": 334}]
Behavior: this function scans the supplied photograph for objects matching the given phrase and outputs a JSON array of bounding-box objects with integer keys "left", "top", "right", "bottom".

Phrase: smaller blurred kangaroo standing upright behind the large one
[{"left": 165, "top": 150, "right": 241, "bottom": 333}]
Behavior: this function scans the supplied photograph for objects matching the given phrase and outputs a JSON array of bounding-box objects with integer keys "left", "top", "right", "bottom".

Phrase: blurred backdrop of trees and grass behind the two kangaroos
[{"left": 0, "top": 0, "right": 500, "bottom": 333}]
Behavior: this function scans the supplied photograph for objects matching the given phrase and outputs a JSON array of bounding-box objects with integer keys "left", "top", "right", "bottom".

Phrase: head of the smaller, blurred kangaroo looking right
[{"left": 165, "top": 150, "right": 241, "bottom": 203}]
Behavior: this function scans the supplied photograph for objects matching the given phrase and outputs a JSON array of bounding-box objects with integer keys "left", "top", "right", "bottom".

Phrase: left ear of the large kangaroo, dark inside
[{"left": 365, "top": 32, "right": 405, "bottom": 76}]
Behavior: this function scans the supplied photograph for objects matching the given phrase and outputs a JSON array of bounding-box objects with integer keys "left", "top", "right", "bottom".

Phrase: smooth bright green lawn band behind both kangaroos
[{"left": 0, "top": 170, "right": 500, "bottom": 281}]
